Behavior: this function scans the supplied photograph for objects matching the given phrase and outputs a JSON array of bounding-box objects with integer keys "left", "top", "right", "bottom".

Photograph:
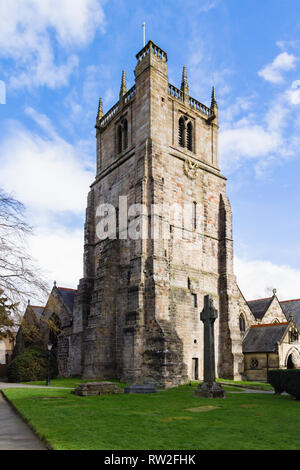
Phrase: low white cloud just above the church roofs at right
[{"left": 235, "top": 258, "right": 300, "bottom": 300}]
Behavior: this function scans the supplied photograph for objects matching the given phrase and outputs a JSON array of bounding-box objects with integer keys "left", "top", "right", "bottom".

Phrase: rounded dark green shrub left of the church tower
[{"left": 7, "top": 347, "right": 58, "bottom": 383}]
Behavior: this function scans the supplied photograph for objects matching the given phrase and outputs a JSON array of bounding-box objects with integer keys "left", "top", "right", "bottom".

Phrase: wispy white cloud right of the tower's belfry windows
[{"left": 219, "top": 75, "right": 300, "bottom": 173}]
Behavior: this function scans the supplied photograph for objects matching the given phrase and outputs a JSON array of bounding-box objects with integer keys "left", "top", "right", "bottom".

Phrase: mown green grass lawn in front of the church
[{"left": 5, "top": 385, "right": 300, "bottom": 450}]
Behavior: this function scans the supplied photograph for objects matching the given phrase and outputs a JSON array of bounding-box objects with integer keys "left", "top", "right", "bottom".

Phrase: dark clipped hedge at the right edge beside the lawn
[{"left": 268, "top": 369, "right": 300, "bottom": 400}]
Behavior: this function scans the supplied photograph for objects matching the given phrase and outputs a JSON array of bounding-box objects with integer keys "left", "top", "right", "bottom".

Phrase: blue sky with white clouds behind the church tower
[{"left": 0, "top": 0, "right": 300, "bottom": 299}]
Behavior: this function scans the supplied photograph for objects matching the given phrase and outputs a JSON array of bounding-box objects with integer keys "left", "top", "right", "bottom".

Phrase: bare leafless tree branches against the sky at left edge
[{"left": 0, "top": 189, "right": 49, "bottom": 313}]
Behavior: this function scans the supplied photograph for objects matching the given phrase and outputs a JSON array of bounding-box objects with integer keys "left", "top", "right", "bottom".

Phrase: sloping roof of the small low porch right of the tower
[{"left": 243, "top": 322, "right": 289, "bottom": 353}]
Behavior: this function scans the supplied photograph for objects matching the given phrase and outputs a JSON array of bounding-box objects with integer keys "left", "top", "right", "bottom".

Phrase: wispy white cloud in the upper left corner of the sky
[{"left": 0, "top": 0, "right": 105, "bottom": 88}]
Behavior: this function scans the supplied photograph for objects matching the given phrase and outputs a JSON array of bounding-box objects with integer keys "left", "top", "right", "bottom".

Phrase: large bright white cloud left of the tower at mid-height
[{"left": 0, "top": 115, "right": 94, "bottom": 214}]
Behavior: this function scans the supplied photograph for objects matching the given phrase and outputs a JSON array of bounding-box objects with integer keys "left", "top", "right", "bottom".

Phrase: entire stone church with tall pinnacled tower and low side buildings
[{"left": 17, "top": 41, "right": 300, "bottom": 387}]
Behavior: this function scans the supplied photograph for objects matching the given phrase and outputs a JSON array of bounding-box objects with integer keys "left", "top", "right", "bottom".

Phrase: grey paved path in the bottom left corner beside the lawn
[{"left": 0, "top": 393, "right": 47, "bottom": 450}]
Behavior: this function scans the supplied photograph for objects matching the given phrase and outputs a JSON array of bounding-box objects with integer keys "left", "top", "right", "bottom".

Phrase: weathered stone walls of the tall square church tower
[{"left": 72, "top": 42, "right": 243, "bottom": 386}]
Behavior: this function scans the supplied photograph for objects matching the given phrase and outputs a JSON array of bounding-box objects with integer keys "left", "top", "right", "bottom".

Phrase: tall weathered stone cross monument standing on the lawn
[{"left": 195, "top": 295, "right": 225, "bottom": 398}]
